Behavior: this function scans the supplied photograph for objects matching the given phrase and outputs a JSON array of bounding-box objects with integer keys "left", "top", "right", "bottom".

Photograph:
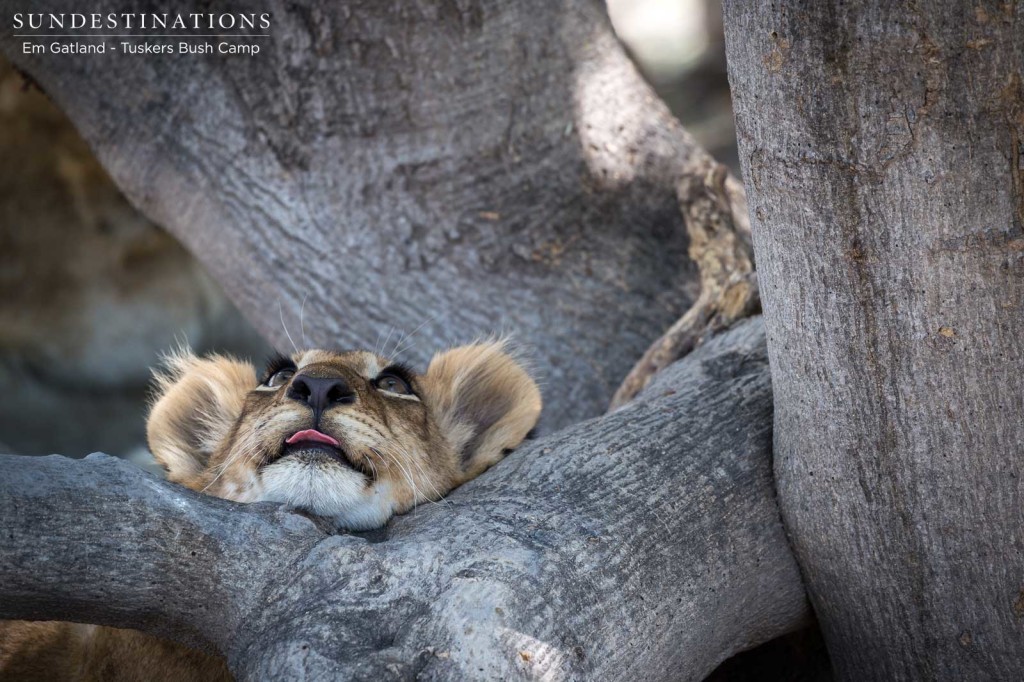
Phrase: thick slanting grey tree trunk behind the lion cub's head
[{"left": 0, "top": 0, "right": 742, "bottom": 430}]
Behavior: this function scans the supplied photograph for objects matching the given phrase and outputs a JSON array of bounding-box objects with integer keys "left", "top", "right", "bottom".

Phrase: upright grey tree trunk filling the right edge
[{"left": 726, "top": 0, "right": 1024, "bottom": 680}]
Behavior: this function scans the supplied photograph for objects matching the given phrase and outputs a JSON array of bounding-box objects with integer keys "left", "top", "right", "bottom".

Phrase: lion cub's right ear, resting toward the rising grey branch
[{"left": 422, "top": 341, "right": 541, "bottom": 480}]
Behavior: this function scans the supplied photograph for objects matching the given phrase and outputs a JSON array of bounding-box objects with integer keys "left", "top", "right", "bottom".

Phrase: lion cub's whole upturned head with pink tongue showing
[{"left": 146, "top": 342, "right": 541, "bottom": 530}]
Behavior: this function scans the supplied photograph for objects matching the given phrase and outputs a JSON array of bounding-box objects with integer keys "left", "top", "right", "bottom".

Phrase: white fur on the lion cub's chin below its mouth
[{"left": 254, "top": 458, "right": 393, "bottom": 530}]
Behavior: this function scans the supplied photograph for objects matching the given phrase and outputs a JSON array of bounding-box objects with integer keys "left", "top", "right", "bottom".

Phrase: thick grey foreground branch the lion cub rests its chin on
[{"left": 0, "top": 321, "right": 807, "bottom": 680}]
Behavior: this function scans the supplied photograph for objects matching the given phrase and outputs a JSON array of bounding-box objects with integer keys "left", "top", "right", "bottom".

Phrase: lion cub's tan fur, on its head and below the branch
[{"left": 0, "top": 341, "right": 541, "bottom": 682}]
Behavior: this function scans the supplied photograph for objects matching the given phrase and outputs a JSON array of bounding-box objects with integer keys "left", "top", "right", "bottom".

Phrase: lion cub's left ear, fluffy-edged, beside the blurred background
[{"left": 145, "top": 350, "right": 258, "bottom": 485}]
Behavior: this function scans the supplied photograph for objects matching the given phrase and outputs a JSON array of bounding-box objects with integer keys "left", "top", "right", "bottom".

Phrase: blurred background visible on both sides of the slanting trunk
[{"left": 0, "top": 0, "right": 738, "bottom": 467}]
